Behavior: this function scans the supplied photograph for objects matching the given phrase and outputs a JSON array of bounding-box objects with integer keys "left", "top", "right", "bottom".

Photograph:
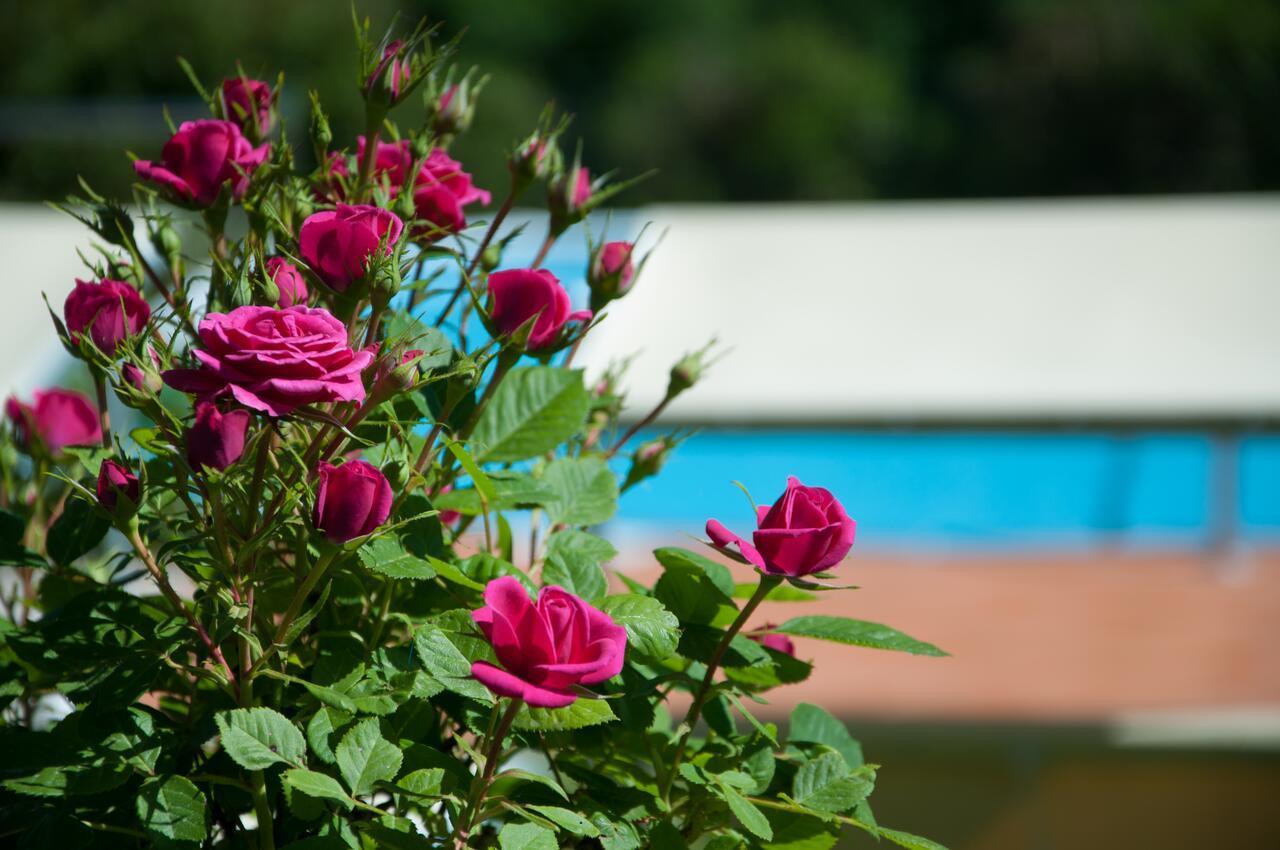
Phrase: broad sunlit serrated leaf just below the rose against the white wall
[{"left": 471, "top": 366, "right": 591, "bottom": 462}]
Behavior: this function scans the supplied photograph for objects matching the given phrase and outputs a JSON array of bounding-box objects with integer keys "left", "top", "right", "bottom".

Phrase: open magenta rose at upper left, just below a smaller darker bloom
[{"left": 133, "top": 119, "right": 271, "bottom": 206}]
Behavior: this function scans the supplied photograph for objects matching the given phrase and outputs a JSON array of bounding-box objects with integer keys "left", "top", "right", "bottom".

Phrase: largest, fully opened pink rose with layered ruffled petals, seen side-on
[{"left": 164, "top": 306, "right": 374, "bottom": 416}]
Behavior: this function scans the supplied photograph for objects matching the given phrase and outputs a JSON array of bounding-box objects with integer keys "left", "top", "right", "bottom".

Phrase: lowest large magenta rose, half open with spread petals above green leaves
[{"left": 471, "top": 576, "right": 627, "bottom": 708}]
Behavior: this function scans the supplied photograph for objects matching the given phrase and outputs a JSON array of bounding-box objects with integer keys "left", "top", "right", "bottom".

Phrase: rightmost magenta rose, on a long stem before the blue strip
[{"left": 707, "top": 475, "right": 856, "bottom": 577}]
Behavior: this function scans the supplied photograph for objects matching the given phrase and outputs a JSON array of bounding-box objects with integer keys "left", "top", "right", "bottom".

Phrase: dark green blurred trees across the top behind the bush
[{"left": 0, "top": 0, "right": 1280, "bottom": 202}]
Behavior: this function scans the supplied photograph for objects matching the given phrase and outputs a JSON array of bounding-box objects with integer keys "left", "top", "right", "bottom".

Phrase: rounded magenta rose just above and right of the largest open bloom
[{"left": 298, "top": 204, "right": 404, "bottom": 292}]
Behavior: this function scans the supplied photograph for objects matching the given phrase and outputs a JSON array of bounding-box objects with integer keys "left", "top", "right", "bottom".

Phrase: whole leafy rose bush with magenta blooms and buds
[{"left": 0, "top": 14, "right": 941, "bottom": 850}]
